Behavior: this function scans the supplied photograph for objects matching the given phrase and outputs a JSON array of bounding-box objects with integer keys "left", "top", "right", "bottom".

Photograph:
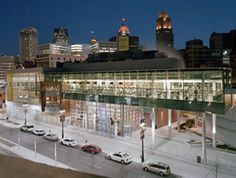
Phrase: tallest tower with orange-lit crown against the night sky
[{"left": 156, "top": 11, "right": 174, "bottom": 51}]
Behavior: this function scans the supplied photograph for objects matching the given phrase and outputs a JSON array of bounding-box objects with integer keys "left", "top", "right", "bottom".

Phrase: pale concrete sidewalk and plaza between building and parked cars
[{"left": 0, "top": 114, "right": 236, "bottom": 178}]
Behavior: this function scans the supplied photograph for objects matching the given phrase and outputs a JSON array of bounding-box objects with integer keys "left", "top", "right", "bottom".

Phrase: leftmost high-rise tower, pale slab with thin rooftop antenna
[{"left": 20, "top": 27, "right": 38, "bottom": 64}]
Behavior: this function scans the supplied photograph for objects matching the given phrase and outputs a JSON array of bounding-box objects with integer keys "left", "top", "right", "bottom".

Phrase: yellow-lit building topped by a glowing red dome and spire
[{"left": 109, "top": 18, "right": 140, "bottom": 51}]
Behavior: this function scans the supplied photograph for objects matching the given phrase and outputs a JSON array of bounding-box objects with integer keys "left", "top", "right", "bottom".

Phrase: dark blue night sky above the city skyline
[{"left": 0, "top": 0, "right": 236, "bottom": 55}]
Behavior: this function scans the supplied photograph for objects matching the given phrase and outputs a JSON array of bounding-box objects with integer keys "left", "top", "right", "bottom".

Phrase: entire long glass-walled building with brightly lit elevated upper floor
[{"left": 7, "top": 59, "right": 232, "bottom": 136}]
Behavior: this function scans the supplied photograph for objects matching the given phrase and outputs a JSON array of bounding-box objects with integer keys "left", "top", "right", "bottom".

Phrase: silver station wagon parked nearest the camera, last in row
[{"left": 142, "top": 162, "right": 171, "bottom": 176}]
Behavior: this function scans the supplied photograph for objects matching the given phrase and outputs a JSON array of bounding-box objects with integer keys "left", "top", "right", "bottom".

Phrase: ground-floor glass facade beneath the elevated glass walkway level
[{"left": 70, "top": 100, "right": 144, "bottom": 136}]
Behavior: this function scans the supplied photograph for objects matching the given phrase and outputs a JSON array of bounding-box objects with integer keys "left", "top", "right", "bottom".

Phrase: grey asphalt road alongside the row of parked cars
[{"left": 0, "top": 125, "right": 179, "bottom": 178}]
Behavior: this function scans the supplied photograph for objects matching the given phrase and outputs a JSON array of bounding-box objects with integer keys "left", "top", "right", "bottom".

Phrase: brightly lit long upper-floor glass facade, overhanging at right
[{"left": 45, "top": 68, "right": 231, "bottom": 112}]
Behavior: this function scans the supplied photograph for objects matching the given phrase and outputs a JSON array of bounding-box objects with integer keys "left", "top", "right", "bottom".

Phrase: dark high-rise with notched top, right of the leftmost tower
[{"left": 52, "top": 27, "right": 68, "bottom": 45}]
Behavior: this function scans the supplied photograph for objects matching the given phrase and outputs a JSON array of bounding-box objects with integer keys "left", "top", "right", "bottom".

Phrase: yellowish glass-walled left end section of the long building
[{"left": 6, "top": 68, "right": 44, "bottom": 121}]
